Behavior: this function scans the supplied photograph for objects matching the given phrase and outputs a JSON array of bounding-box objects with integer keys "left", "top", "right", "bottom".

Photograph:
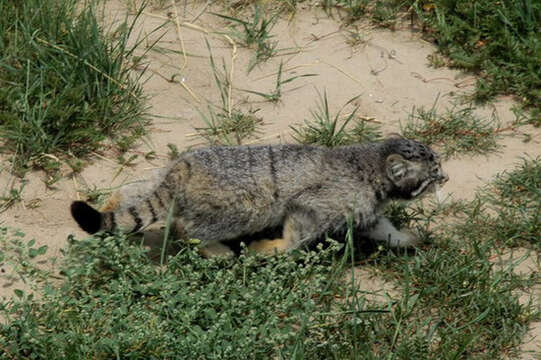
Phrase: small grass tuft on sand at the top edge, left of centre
[{"left": 215, "top": 3, "right": 280, "bottom": 72}]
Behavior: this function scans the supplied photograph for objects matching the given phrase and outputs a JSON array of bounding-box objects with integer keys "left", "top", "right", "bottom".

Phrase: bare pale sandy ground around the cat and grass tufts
[{"left": 0, "top": 1, "right": 541, "bottom": 358}]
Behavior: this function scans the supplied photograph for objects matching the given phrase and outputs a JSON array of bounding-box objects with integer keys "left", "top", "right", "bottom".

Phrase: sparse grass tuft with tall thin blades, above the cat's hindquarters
[{"left": 195, "top": 42, "right": 263, "bottom": 145}]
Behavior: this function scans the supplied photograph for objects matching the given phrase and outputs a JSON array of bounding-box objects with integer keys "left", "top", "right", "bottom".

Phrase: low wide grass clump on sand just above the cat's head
[{"left": 402, "top": 99, "right": 502, "bottom": 158}]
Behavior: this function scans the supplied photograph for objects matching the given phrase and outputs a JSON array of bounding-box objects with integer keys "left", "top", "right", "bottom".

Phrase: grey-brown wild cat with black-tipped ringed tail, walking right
[{"left": 71, "top": 136, "right": 449, "bottom": 255}]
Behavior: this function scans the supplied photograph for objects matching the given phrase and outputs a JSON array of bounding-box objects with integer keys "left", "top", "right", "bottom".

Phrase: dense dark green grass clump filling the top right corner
[{"left": 418, "top": 0, "right": 541, "bottom": 108}]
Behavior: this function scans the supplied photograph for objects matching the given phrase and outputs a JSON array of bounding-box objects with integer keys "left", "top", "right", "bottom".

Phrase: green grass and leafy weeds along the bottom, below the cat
[{"left": 0, "top": 159, "right": 541, "bottom": 360}]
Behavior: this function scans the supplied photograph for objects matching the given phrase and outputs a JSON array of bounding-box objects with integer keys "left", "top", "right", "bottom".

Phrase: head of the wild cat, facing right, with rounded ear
[{"left": 384, "top": 137, "right": 449, "bottom": 200}]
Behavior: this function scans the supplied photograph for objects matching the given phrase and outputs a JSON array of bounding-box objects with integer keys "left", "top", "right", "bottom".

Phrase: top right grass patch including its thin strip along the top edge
[{"left": 312, "top": 0, "right": 541, "bottom": 109}]
